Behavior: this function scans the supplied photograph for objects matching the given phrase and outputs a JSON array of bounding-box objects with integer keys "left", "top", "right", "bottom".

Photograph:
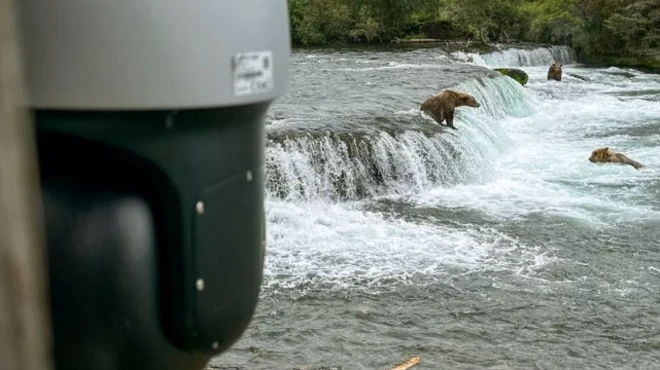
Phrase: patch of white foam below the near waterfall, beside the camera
[{"left": 264, "top": 199, "right": 553, "bottom": 292}]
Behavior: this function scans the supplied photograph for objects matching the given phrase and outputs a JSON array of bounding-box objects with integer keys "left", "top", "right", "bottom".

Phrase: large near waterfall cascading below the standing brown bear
[{"left": 266, "top": 76, "right": 531, "bottom": 199}]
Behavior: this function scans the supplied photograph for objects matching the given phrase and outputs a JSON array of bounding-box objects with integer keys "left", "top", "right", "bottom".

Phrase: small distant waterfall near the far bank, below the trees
[{"left": 452, "top": 46, "right": 577, "bottom": 67}]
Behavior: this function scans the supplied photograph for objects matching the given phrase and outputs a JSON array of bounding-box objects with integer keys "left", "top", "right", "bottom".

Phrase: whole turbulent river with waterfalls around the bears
[{"left": 210, "top": 47, "right": 660, "bottom": 370}]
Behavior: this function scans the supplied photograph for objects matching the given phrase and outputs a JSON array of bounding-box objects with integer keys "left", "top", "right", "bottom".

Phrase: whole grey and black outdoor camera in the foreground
[{"left": 18, "top": 0, "right": 290, "bottom": 370}]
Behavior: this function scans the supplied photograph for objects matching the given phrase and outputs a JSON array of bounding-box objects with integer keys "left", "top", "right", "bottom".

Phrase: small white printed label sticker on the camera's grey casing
[{"left": 231, "top": 50, "right": 273, "bottom": 96}]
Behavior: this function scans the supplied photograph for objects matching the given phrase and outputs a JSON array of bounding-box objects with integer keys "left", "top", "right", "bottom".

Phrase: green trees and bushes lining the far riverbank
[{"left": 289, "top": 0, "right": 660, "bottom": 62}]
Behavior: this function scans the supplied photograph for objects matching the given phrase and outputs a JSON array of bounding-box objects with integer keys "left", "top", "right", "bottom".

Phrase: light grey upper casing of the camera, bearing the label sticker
[{"left": 17, "top": 0, "right": 291, "bottom": 110}]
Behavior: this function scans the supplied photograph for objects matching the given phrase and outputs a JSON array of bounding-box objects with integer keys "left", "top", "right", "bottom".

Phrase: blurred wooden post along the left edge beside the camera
[{"left": 0, "top": 0, "right": 52, "bottom": 370}]
